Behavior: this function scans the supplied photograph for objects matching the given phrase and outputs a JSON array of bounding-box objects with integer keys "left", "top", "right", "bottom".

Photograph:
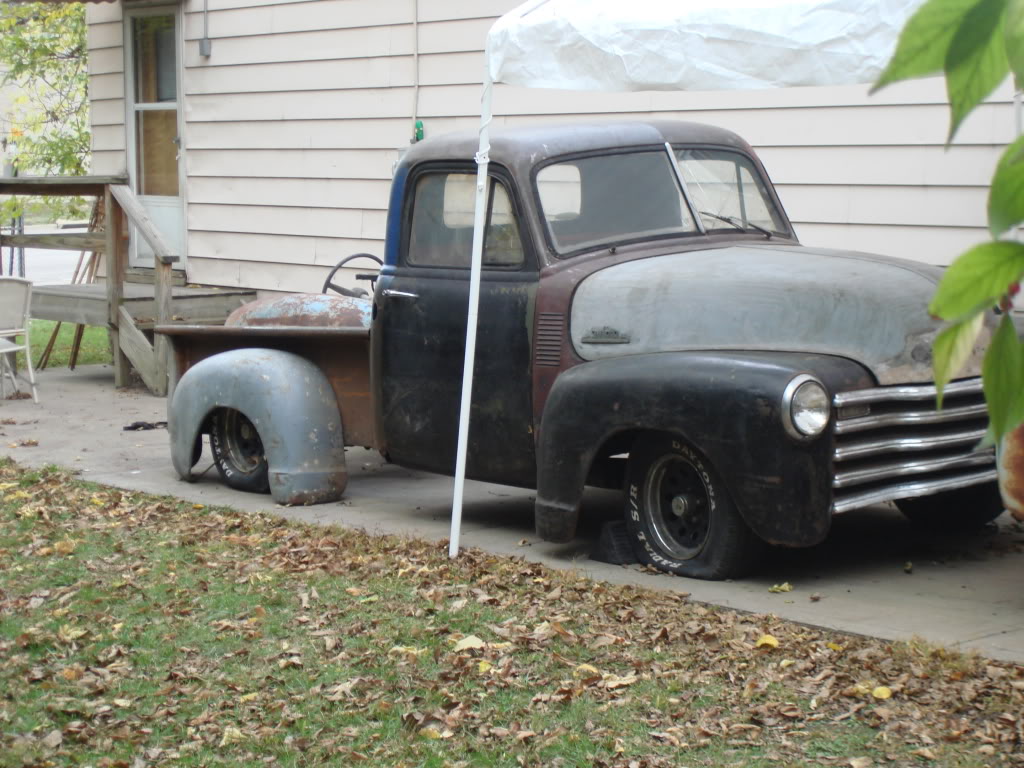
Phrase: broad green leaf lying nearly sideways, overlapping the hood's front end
[{"left": 928, "top": 241, "right": 1024, "bottom": 323}]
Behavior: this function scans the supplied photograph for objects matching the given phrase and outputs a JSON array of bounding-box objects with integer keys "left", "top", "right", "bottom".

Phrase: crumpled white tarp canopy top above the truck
[{"left": 486, "top": 0, "right": 923, "bottom": 91}]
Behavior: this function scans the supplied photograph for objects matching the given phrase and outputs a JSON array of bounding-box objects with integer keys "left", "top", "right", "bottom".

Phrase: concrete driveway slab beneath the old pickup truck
[{"left": 0, "top": 366, "right": 1024, "bottom": 663}]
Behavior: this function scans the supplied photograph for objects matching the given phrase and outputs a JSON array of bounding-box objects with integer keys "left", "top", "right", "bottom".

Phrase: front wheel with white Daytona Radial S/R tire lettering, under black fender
[{"left": 626, "top": 435, "right": 764, "bottom": 580}]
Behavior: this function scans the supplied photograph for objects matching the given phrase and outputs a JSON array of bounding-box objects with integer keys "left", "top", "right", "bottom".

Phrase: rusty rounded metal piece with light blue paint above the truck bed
[{"left": 224, "top": 293, "right": 372, "bottom": 329}]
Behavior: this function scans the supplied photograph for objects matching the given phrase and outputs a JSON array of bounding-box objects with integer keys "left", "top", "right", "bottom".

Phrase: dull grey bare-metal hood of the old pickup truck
[{"left": 570, "top": 243, "right": 994, "bottom": 384}]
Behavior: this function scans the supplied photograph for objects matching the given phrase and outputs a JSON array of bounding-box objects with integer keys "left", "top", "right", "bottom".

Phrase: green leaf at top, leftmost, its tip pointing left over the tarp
[{"left": 871, "top": 0, "right": 983, "bottom": 93}]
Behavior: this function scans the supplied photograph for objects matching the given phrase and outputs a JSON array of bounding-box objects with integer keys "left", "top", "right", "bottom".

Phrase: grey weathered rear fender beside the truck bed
[{"left": 168, "top": 349, "right": 348, "bottom": 505}]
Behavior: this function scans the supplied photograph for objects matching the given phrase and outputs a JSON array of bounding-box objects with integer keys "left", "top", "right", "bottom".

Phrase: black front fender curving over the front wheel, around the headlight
[{"left": 537, "top": 352, "right": 874, "bottom": 546}]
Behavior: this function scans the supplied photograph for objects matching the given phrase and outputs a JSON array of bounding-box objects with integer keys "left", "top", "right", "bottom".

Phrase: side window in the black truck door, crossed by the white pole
[{"left": 407, "top": 173, "right": 523, "bottom": 269}]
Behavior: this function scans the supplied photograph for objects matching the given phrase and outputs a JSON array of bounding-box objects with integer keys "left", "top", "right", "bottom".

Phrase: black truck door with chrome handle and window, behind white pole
[{"left": 373, "top": 166, "right": 538, "bottom": 486}]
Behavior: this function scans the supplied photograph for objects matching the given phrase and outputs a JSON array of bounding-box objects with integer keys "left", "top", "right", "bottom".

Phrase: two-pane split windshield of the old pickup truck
[{"left": 537, "top": 148, "right": 786, "bottom": 254}]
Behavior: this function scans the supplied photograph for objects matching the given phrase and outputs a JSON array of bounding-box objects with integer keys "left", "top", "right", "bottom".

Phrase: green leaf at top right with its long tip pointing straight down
[{"left": 945, "top": 0, "right": 1010, "bottom": 143}]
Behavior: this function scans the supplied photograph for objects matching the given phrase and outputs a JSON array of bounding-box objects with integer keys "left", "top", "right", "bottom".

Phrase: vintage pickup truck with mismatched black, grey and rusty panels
[{"left": 162, "top": 121, "right": 1002, "bottom": 579}]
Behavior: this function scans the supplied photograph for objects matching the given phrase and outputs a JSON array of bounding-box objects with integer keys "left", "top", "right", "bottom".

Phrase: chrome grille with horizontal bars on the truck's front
[{"left": 833, "top": 379, "right": 995, "bottom": 513}]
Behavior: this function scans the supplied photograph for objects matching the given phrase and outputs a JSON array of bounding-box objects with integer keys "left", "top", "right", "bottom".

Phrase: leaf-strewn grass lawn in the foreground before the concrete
[{"left": 0, "top": 460, "right": 1024, "bottom": 768}]
